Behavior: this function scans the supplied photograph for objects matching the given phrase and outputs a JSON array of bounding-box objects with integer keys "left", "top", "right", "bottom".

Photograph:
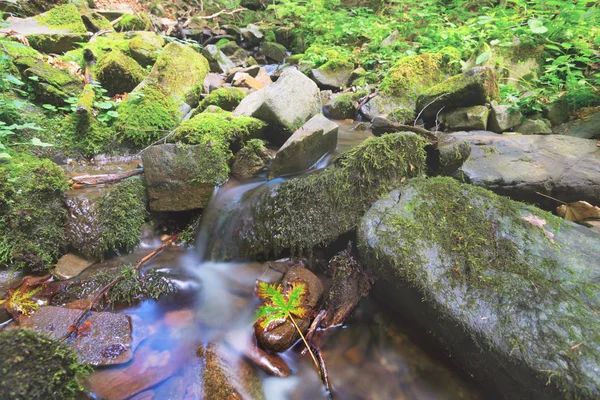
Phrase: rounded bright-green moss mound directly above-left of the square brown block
[{"left": 116, "top": 86, "right": 180, "bottom": 146}]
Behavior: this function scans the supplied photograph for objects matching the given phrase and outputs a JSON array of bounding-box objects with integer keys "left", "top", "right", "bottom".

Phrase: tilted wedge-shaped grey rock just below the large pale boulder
[{"left": 269, "top": 114, "right": 338, "bottom": 179}]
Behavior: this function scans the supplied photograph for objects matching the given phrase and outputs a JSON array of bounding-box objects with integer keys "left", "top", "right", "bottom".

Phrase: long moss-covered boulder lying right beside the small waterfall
[{"left": 207, "top": 133, "right": 425, "bottom": 259}]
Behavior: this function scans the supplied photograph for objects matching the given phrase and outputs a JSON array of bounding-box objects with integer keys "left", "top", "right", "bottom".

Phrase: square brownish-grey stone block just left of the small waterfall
[{"left": 142, "top": 144, "right": 215, "bottom": 211}]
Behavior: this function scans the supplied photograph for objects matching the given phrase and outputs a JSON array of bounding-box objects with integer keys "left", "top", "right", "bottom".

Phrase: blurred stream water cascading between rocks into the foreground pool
[{"left": 76, "top": 121, "right": 484, "bottom": 400}]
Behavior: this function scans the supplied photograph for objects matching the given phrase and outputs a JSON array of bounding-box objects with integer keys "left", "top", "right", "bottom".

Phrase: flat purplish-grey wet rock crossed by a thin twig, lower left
[{"left": 21, "top": 306, "right": 135, "bottom": 366}]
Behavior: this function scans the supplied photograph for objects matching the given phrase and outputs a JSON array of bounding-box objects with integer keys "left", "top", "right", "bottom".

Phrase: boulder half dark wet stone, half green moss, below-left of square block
[{"left": 65, "top": 177, "right": 147, "bottom": 258}]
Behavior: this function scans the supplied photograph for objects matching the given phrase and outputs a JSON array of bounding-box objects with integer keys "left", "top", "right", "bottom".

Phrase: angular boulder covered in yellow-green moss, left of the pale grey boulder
[{"left": 146, "top": 42, "right": 210, "bottom": 107}]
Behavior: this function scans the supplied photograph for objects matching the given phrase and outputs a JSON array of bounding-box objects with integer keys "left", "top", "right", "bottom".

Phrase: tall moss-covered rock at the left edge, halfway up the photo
[{"left": 0, "top": 154, "right": 68, "bottom": 271}]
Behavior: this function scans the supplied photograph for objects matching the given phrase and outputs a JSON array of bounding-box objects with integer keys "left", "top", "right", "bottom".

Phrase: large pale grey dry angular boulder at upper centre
[{"left": 233, "top": 69, "right": 321, "bottom": 144}]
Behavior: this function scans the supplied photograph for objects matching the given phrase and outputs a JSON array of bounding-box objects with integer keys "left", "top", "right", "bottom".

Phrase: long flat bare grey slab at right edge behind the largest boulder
[{"left": 453, "top": 132, "right": 600, "bottom": 209}]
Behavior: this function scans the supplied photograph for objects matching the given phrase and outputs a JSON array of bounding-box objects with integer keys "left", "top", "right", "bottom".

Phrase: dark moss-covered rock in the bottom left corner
[{"left": 0, "top": 329, "right": 89, "bottom": 400}]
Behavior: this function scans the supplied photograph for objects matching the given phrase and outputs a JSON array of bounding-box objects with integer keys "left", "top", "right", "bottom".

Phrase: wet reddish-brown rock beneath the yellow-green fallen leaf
[{"left": 254, "top": 265, "right": 323, "bottom": 352}]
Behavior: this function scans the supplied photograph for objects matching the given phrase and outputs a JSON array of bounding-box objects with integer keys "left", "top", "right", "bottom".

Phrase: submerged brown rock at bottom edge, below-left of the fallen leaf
[{"left": 198, "top": 343, "right": 264, "bottom": 400}]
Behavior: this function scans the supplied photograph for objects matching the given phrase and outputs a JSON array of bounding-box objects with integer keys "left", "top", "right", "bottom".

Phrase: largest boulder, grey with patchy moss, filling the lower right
[{"left": 358, "top": 178, "right": 600, "bottom": 399}]
